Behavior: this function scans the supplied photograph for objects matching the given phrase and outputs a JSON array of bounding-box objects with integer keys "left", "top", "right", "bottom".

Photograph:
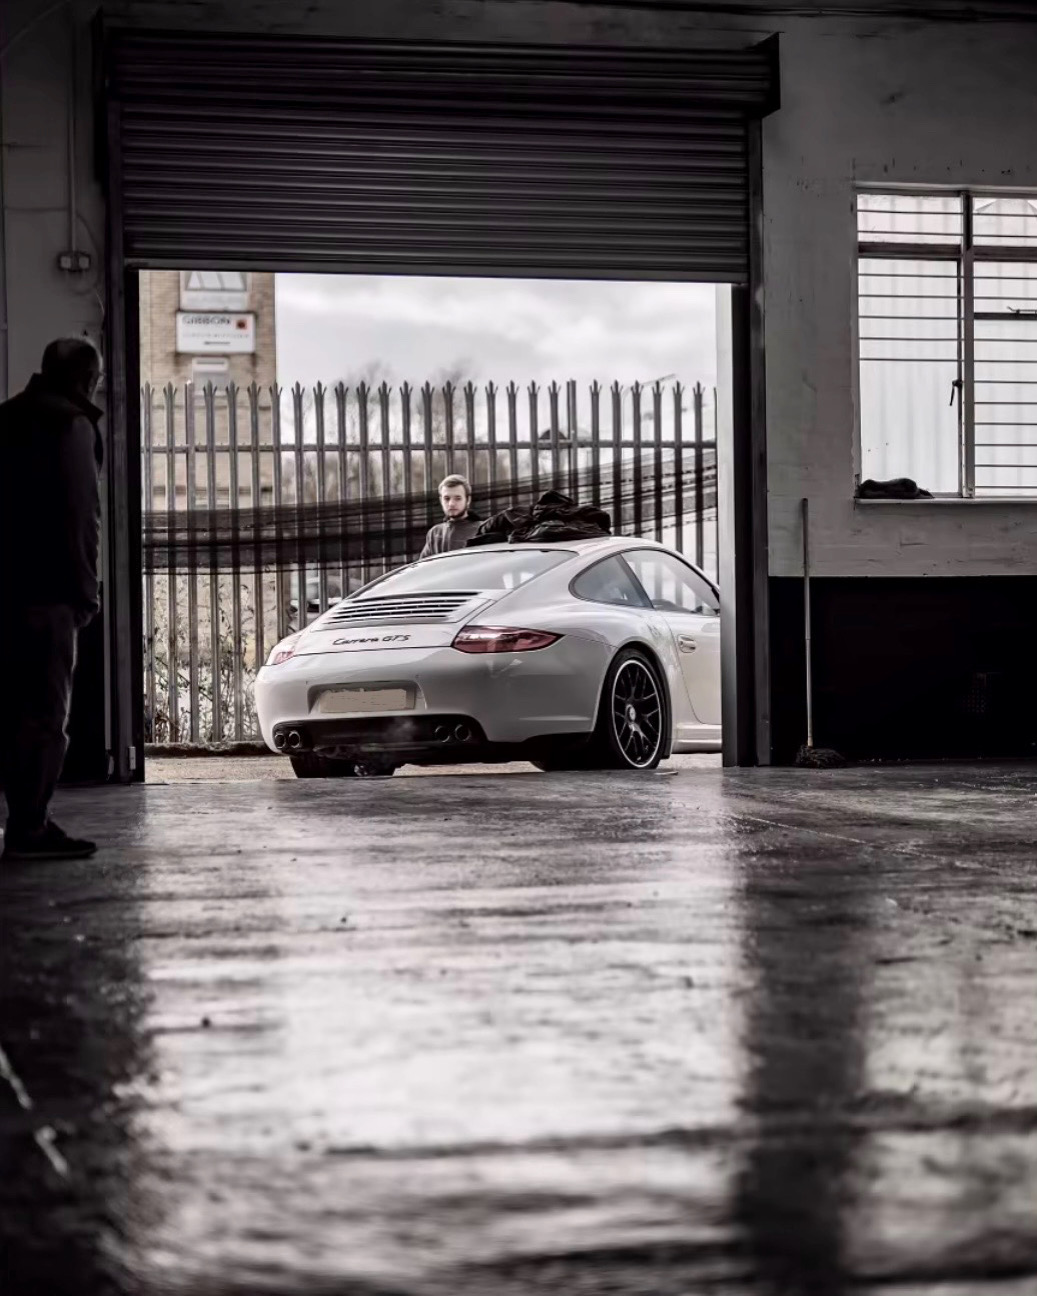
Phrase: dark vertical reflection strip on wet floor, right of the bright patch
[{"left": 734, "top": 857, "right": 874, "bottom": 1296}]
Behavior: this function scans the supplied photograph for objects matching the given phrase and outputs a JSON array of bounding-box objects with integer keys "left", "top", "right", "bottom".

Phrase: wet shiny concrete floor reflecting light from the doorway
[{"left": 0, "top": 766, "right": 1037, "bottom": 1296}]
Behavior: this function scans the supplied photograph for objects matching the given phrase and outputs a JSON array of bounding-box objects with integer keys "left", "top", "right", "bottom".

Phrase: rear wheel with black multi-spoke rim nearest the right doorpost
[{"left": 587, "top": 648, "right": 670, "bottom": 770}]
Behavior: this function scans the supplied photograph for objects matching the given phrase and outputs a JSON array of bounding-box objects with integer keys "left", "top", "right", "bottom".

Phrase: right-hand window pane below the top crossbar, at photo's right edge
[{"left": 975, "top": 260, "right": 1037, "bottom": 496}]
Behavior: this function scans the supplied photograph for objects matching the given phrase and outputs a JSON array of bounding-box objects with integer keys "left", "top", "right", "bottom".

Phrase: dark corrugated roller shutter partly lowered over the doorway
[{"left": 106, "top": 31, "right": 776, "bottom": 283}]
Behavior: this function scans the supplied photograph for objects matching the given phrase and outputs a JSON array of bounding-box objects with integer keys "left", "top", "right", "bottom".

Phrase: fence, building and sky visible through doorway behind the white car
[{"left": 137, "top": 271, "right": 717, "bottom": 778}]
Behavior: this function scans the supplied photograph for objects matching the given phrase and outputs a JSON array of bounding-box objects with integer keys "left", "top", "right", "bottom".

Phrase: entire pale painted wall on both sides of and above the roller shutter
[{"left": 0, "top": 0, "right": 1037, "bottom": 575}]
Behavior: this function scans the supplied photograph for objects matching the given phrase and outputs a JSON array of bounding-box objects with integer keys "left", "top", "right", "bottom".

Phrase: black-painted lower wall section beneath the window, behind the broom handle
[{"left": 770, "top": 577, "right": 1037, "bottom": 765}]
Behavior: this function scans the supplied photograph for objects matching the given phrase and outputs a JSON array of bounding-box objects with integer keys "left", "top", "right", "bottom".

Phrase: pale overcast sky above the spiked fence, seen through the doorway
[{"left": 276, "top": 275, "right": 716, "bottom": 388}]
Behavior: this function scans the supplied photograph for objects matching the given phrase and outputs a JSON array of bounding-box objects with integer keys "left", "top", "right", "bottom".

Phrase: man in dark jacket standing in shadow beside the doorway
[{"left": 0, "top": 338, "right": 102, "bottom": 859}]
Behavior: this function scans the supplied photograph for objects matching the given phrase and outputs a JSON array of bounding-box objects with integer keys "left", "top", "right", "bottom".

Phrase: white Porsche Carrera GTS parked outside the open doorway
[{"left": 255, "top": 537, "right": 721, "bottom": 778}]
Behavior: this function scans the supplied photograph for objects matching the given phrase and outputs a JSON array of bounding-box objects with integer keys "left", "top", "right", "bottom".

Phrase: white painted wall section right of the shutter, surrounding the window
[{"left": 763, "top": 22, "right": 1037, "bottom": 575}]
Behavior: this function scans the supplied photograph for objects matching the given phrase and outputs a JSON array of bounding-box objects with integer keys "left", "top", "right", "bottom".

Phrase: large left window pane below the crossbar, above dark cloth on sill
[{"left": 858, "top": 257, "right": 961, "bottom": 495}]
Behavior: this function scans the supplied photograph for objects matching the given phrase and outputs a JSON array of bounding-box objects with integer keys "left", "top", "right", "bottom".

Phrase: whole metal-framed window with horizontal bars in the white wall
[{"left": 857, "top": 189, "right": 1037, "bottom": 499}]
